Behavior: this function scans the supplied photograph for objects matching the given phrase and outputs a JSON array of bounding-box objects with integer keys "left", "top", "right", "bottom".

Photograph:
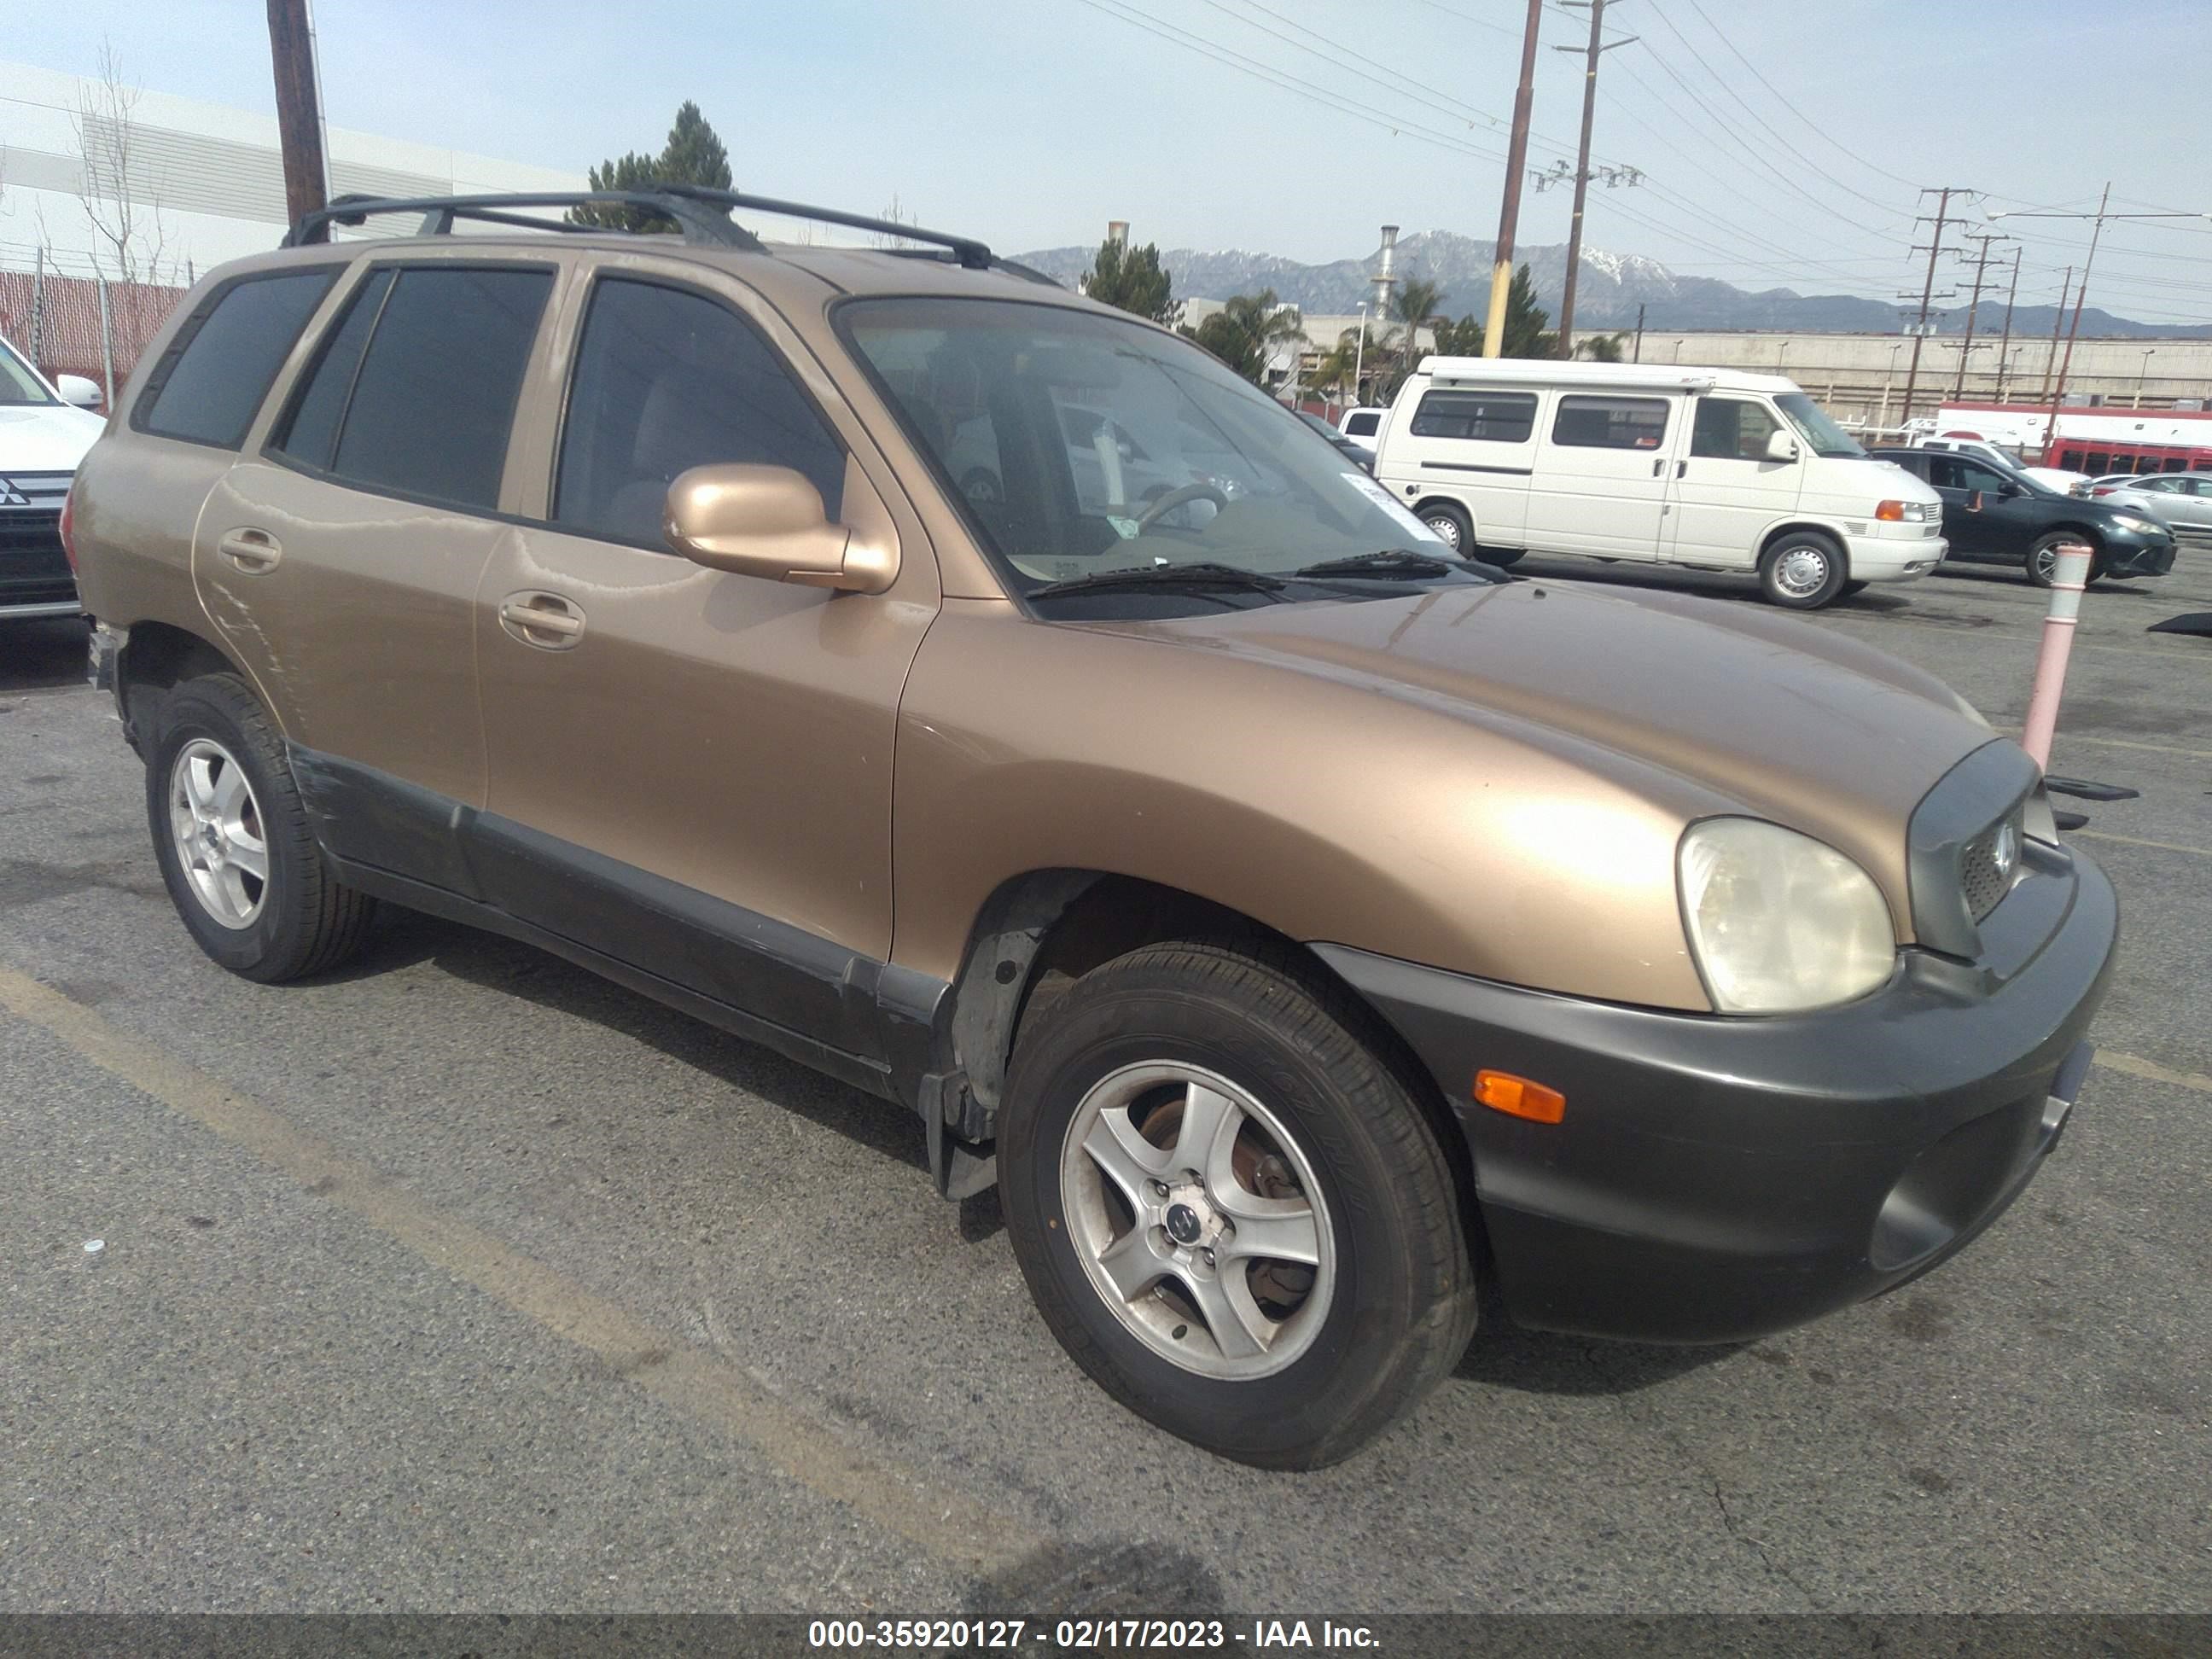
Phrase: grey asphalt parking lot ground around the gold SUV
[{"left": 0, "top": 549, "right": 2212, "bottom": 1615}]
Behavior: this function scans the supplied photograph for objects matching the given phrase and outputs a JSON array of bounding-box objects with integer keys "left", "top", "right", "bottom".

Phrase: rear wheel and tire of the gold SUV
[{"left": 146, "top": 675, "right": 376, "bottom": 984}]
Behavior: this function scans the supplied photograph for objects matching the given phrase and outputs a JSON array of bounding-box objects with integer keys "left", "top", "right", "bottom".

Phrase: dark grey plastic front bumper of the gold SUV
[{"left": 1316, "top": 843, "right": 2119, "bottom": 1342}]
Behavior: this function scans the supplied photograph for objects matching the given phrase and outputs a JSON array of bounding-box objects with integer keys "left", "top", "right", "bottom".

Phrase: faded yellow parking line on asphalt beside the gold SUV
[{"left": 0, "top": 967, "right": 1042, "bottom": 1570}]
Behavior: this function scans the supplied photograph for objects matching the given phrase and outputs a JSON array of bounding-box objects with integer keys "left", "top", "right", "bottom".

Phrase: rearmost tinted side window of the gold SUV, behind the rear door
[{"left": 131, "top": 265, "right": 339, "bottom": 449}]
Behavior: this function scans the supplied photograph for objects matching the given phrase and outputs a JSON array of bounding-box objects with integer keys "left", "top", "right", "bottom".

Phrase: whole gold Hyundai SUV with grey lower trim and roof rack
[{"left": 67, "top": 190, "right": 2117, "bottom": 1466}]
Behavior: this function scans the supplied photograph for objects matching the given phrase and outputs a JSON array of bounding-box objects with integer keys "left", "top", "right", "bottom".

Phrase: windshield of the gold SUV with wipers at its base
[{"left": 838, "top": 299, "right": 1466, "bottom": 599}]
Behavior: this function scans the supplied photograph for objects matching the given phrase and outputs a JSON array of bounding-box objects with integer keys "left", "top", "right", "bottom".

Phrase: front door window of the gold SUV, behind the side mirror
[{"left": 553, "top": 276, "right": 845, "bottom": 550}]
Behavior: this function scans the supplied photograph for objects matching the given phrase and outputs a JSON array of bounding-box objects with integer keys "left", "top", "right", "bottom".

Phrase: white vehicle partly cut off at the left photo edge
[{"left": 0, "top": 341, "right": 106, "bottom": 621}]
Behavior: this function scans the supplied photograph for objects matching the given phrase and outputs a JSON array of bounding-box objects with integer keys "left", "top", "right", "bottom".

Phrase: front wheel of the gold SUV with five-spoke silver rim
[{"left": 998, "top": 942, "right": 1476, "bottom": 1469}]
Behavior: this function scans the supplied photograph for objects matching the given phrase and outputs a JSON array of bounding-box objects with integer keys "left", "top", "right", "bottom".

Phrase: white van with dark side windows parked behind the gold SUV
[{"left": 1376, "top": 356, "right": 1944, "bottom": 610}]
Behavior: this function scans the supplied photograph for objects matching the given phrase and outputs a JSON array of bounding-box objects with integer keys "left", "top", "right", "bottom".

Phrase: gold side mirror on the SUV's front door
[{"left": 661, "top": 463, "right": 898, "bottom": 593}]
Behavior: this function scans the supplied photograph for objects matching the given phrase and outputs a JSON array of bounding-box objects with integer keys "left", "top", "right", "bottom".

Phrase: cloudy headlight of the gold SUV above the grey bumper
[{"left": 1677, "top": 818, "right": 1898, "bottom": 1013}]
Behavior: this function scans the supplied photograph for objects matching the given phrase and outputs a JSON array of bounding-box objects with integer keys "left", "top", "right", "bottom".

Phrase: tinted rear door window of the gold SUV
[{"left": 276, "top": 265, "right": 553, "bottom": 511}]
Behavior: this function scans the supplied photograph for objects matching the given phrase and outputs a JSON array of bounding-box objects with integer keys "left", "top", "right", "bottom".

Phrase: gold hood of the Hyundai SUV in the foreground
[{"left": 1121, "top": 578, "right": 2004, "bottom": 923}]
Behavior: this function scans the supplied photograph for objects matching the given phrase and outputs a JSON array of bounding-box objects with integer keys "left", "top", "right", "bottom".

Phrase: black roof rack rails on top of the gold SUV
[{"left": 279, "top": 182, "right": 1004, "bottom": 274}]
